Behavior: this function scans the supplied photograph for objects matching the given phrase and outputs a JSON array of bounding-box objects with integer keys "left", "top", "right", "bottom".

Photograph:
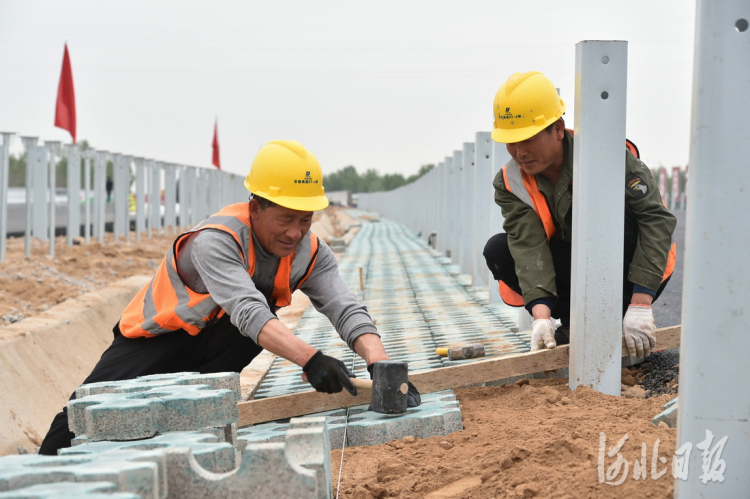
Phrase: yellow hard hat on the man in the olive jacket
[{"left": 492, "top": 71, "right": 565, "bottom": 144}]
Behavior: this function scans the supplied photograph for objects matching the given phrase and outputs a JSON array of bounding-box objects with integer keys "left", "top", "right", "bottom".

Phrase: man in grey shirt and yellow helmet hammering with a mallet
[{"left": 40, "top": 140, "right": 421, "bottom": 455}]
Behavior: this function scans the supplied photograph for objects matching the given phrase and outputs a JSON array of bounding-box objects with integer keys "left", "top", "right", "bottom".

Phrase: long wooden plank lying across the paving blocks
[{"left": 237, "top": 326, "right": 681, "bottom": 427}]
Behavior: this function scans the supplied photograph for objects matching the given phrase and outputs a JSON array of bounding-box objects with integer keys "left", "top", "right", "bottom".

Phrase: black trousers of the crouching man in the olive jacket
[{"left": 484, "top": 205, "right": 671, "bottom": 326}]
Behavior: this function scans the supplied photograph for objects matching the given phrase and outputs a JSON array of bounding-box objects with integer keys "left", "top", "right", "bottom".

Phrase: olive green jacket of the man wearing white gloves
[{"left": 492, "top": 131, "right": 677, "bottom": 305}]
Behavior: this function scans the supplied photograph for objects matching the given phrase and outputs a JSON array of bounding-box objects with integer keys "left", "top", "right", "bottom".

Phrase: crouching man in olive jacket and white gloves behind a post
[{"left": 484, "top": 71, "right": 676, "bottom": 358}]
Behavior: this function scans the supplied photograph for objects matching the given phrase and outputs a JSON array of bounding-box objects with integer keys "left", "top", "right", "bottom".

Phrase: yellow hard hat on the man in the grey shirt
[{"left": 245, "top": 140, "right": 328, "bottom": 211}]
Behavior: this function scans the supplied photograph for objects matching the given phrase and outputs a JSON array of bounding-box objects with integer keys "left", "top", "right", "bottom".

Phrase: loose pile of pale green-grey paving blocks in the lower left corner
[{"left": 0, "top": 373, "right": 331, "bottom": 499}]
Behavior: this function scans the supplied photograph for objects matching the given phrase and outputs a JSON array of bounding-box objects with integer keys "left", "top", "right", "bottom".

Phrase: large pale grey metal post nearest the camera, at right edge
[{"left": 680, "top": 0, "right": 750, "bottom": 499}]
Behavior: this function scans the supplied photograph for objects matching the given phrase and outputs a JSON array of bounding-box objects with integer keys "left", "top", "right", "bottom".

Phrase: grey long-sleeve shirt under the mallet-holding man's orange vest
[{"left": 178, "top": 230, "right": 377, "bottom": 348}]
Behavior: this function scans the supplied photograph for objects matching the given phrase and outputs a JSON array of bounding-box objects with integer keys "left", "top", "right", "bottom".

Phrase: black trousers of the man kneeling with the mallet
[{"left": 39, "top": 315, "right": 263, "bottom": 456}]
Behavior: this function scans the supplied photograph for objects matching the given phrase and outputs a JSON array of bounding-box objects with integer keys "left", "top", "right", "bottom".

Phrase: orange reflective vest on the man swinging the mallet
[{"left": 120, "top": 203, "right": 319, "bottom": 338}]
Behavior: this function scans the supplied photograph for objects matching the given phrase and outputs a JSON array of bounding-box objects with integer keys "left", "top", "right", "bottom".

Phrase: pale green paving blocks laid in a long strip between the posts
[{"left": 238, "top": 211, "right": 529, "bottom": 448}]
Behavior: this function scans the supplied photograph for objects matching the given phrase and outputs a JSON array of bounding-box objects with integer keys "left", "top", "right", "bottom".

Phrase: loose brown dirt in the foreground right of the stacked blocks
[{"left": 338, "top": 379, "right": 676, "bottom": 499}]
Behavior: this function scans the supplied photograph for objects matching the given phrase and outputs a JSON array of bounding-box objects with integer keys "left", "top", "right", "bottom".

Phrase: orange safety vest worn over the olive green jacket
[{"left": 498, "top": 137, "right": 677, "bottom": 307}]
